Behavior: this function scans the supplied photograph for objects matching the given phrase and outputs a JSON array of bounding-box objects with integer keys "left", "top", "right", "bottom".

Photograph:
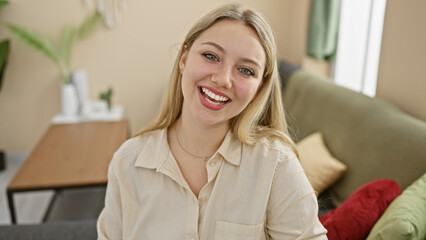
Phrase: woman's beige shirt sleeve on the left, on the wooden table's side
[{"left": 97, "top": 155, "right": 123, "bottom": 240}]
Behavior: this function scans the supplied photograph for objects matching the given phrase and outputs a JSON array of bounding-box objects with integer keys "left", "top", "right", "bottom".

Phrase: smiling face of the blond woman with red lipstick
[{"left": 179, "top": 20, "right": 266, "bottom": 129}]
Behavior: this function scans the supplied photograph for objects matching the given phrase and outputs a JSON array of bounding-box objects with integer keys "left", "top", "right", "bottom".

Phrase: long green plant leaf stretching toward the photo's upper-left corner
[{"left": 5, "top": 23, "right": 61, "bottom": 66}]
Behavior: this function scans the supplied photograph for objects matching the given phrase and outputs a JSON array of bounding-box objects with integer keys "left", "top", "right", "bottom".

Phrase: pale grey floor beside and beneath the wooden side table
[{"left": 0, "top": 153, "right": 53, "bottom": 225}]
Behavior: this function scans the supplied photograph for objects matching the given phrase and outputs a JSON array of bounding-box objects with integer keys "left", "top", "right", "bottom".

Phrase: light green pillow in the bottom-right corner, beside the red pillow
[{"left": 367, "top": 174, "right": 426, "bottom": 240}]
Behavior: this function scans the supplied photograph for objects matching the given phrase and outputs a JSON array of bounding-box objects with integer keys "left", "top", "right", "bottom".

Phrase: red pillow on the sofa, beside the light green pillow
[{"left": 319, "top": 179, "right": 401, "bottom": 240}]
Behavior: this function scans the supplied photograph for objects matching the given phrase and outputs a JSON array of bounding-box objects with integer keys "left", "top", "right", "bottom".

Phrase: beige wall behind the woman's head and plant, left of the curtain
[{"left": 0, "top": 0, "right": 296, "bottom": 152}]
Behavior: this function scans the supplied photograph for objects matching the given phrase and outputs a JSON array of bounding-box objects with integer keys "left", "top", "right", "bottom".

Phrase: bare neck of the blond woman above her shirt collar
[{"left": 174, "top": 115, "right": 229, "bottom": 156}]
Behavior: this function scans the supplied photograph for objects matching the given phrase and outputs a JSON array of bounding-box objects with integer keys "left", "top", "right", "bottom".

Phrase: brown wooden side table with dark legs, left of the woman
[{"left": 7, "top": 121, "right": 129, "bottom": 223}]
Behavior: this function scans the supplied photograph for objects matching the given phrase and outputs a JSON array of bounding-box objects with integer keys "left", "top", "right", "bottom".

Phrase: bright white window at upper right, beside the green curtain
[{"left": 332, "top": 0, "right": 386, "bottom": 97}]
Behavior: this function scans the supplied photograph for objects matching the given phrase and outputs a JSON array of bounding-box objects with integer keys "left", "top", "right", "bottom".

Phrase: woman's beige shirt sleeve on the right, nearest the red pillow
[{"left": 266, "top": 153, "right": 327, "bottom": 240}]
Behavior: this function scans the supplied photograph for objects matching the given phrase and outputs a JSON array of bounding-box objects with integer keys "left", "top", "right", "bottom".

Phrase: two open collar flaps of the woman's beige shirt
[{"left": 134, "top": 128, "right": 243, "bottom": 169}]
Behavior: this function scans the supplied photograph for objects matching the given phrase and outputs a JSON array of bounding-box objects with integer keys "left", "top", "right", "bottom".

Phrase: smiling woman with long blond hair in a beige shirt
[{"left": 98, "top": 5, "right": 326, "bottom": 240}]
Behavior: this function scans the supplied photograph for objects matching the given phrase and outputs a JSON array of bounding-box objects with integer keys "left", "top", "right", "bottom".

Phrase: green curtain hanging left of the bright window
[{"left": 308, "top": 0, "right": 340, "bottom": 60}]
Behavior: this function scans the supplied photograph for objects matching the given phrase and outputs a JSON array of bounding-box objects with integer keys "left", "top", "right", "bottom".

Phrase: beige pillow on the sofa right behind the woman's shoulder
[{"left": 296, "top": 132, "right": 346, "bottom": 194}]
